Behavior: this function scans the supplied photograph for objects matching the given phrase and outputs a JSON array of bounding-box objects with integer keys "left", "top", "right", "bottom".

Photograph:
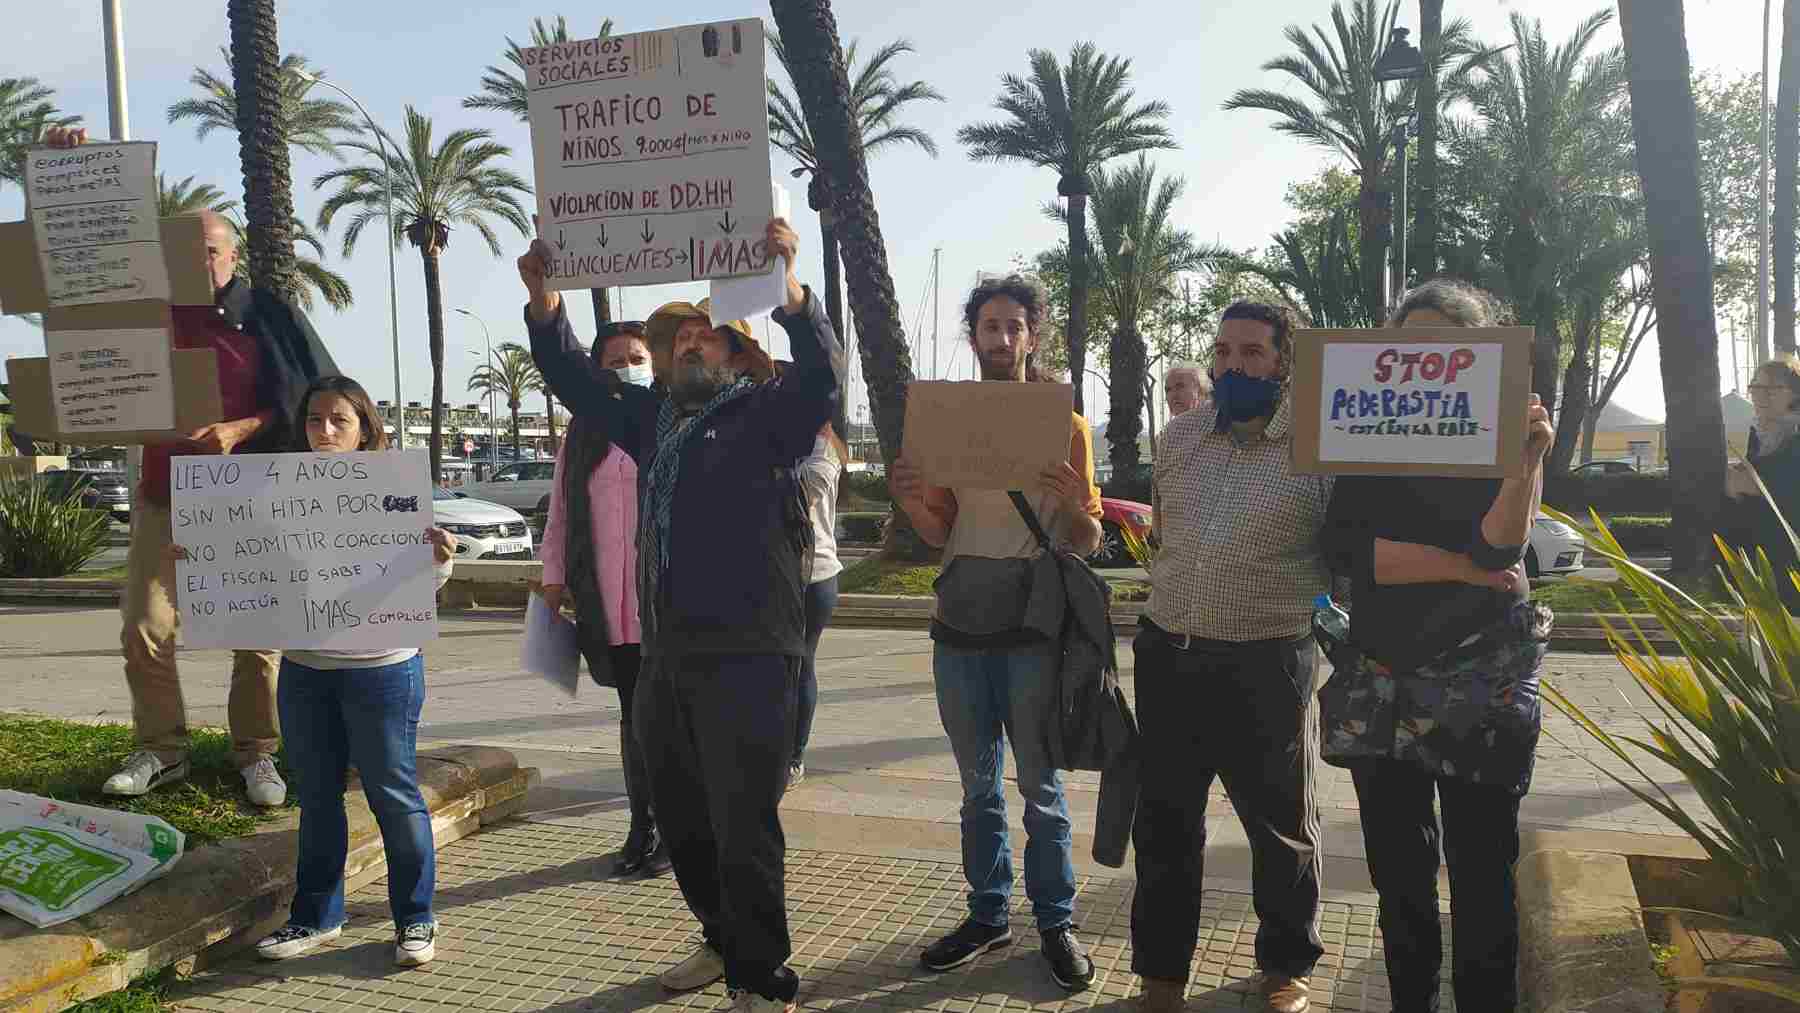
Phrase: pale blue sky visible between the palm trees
[{"left": 0, "top": 0, "right": 1780, "bottom": 417}]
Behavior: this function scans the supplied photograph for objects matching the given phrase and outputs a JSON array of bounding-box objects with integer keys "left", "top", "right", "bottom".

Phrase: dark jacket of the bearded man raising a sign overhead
[{"left": 526, "top": 291, "right": 844, "bottom": 659}]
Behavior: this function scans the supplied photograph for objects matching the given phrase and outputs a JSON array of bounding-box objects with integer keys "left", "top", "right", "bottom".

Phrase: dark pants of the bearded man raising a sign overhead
[{"left": 634, "top": 655, "right": 801, "bottom": 1000}]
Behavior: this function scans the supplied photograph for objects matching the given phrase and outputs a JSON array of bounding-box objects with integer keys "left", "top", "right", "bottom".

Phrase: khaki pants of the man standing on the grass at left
[{"left": 119, "top": 497, "right": 281, "bottom": 768}]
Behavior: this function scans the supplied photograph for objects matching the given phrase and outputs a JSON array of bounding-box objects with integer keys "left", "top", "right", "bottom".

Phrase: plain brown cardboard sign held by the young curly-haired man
[{"left": 902, "top": 380, "right": 1075, "bottom": 489}]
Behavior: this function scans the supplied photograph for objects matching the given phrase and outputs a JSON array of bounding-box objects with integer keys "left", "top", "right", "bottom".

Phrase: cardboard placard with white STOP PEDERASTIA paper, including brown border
[{"left": 1289, "top": 327, "right": 1532, "bottom": 479}]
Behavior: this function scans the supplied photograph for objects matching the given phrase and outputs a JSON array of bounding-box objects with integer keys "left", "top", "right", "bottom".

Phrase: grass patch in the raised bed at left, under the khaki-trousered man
[{"left": 0, "top": 714, "right": 295, "bottom": 847}]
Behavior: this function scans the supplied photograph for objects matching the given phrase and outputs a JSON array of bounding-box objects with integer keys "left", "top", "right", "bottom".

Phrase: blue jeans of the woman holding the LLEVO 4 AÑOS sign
[{"left": 275, "top": 655, "right": 437, "bottom": 930}]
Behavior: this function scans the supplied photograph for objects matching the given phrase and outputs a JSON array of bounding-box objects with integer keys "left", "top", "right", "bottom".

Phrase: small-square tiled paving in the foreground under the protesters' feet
[{"left": 173, "top": 815, "right": 1432, "bottom": 1013}]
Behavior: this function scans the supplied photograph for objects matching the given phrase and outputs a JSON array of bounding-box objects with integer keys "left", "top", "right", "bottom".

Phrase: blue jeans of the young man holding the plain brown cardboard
[{"left": 932, "top": 642, "right": 1075, "bottom": 930}]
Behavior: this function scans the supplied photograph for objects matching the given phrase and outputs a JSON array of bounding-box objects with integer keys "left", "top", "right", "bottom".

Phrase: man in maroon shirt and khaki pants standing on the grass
[{"left": 45, "top": 128, "right": 337, "bottom": 806}]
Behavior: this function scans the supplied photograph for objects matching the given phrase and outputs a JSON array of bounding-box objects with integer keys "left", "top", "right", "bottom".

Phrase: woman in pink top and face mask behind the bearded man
[{"left": 542, "top": 320, "right": 670, "bottom": 876}]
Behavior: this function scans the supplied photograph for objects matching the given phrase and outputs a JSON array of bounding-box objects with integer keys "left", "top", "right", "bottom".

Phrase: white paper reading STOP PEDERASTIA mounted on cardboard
[{"left": 1319, "top": 342, "right": 1503, "bottom": 464}]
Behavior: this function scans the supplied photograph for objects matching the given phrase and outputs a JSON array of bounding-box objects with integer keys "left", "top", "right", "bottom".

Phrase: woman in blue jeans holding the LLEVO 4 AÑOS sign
[{"left": 208, "top": 376, "right": 455, "bottom": 966}]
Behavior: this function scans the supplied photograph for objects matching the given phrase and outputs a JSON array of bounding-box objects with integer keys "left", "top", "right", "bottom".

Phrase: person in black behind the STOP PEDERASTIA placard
[{"left": 1323, "top": 281, "right": 1555, "bottom": 1013}]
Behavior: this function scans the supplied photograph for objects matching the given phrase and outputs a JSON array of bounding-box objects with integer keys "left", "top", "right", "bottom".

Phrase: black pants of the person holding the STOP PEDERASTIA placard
[{"left": 1352, "top": 759, "right": 1519, "bottom": 1013}]
